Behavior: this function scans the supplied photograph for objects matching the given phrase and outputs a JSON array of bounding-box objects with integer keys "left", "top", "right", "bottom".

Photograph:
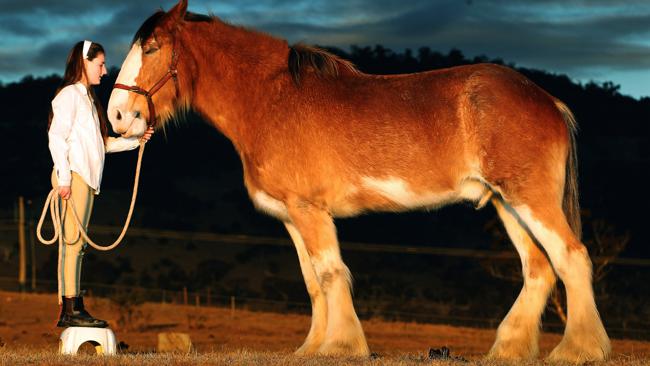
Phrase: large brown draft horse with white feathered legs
[{"left": 108, "top": 0, "right": 610, "bottom": 362}]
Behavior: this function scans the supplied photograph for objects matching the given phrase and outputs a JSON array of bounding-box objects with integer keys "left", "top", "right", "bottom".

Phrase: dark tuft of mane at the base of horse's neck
[{"left": 289, "top": 43, "right": 359, "bottom": 85}]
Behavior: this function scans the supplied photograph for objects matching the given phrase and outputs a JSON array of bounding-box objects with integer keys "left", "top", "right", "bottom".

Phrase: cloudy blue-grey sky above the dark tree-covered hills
[{"left": 0, "top": 0, "right": 650, "bottom": 98}]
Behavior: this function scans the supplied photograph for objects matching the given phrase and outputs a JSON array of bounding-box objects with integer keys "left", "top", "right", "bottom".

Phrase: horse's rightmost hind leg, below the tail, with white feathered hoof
[{"left": 514, "top": 204, "right": 611, "bottom": 363}]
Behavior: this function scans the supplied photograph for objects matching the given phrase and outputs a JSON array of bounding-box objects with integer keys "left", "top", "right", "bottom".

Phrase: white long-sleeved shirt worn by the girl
[{"left": 48, "top": 83, "right": 140, "bottom": 194}]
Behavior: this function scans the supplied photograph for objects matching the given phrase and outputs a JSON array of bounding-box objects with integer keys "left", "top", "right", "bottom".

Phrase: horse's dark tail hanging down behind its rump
[{"left": 555, "top": 99, "right": 582, "bottom": 240}]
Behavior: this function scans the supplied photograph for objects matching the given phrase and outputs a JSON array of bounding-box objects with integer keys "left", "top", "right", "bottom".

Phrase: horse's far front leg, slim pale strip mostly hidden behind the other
[{"left": 284, "top": 222, "right": 327, "bottom": 355}]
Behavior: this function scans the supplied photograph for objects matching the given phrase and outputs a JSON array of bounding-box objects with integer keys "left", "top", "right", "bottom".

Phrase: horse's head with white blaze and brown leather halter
[{"left": 108, "top": 0, "right": 187, "bottom": 137}]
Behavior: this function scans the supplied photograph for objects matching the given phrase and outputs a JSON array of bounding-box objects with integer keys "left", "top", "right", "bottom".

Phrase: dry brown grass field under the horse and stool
[{"left": 0, "top": 292, "right": 650, "bottom": 366}]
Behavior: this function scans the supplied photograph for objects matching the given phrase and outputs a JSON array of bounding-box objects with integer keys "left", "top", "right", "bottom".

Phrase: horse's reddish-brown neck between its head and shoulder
[{"left": 181, "top": 22, "right": 290, "bottom": 149}]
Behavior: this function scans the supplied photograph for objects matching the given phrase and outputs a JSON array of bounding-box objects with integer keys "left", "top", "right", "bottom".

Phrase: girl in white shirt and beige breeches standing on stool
[{"left": 48, "top": 41, "right": 153, "bottom": 328}]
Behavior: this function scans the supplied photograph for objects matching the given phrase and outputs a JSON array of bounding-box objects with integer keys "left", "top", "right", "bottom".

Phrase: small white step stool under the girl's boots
[{"left": 59, "top": 327, "right": 117, "bottom": 355}]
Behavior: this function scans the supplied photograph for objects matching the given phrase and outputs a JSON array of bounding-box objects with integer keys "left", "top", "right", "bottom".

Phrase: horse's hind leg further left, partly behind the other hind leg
[{"left": 488, "top": 198, "right": 555, "bottom": 359}]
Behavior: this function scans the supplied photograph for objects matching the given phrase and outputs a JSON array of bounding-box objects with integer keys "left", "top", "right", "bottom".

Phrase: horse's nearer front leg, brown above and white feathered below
[{"left": 287, "top": 201, "right": 370, "bottom": 356}]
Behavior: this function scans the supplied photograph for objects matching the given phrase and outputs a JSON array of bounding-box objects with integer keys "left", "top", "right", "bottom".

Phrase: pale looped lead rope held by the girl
[{"left": 36, "top": 141, "right": 146, "bottom": 251}]
